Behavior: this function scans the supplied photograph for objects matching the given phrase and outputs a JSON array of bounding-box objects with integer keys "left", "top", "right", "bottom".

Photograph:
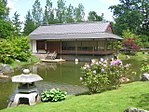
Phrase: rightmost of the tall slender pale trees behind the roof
[{"left": 74, "top": 4, "right": 85, "bottom": 22}]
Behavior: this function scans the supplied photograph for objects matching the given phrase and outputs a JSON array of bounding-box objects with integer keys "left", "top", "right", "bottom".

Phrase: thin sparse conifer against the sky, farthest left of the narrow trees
[{"left": 12, "top": 12, "right": 22, "bottom": 35}]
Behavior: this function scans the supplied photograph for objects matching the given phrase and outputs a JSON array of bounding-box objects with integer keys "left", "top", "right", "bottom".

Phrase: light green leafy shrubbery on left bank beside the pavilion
[{"left": 0, "top": 36, "right": 31, "bottom": 64}]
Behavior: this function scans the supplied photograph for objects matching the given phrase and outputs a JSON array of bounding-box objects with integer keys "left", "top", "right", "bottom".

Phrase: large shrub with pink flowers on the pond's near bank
[{"left": 80, "top": 59, "right": 134, "bottom": 93}]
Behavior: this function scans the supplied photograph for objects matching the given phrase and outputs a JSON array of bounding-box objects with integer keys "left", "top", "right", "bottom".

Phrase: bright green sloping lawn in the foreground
[{"left": 0, "top": 81, "right": 149, "bottom": 112}]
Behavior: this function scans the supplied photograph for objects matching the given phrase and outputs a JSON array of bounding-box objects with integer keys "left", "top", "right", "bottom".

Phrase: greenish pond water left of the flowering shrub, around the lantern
[{"left": 0, "top": 62, "right": 87, "bottom": 109}]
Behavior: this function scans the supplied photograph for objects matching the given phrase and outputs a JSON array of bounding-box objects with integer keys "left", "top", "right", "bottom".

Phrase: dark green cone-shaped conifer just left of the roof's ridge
[{"left": 23, "top": 11, "right": 37, "bottom": 36}]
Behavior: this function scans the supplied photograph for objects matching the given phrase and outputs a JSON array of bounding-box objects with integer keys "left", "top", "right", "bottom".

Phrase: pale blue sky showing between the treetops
[{"left": 8, "top": 0, "right": 119, "bottom": 21}]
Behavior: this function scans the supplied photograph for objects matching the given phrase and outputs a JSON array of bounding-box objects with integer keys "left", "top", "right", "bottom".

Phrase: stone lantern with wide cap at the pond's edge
[{"left": 8, "top": 69, "right": 43, "bottom": 107}]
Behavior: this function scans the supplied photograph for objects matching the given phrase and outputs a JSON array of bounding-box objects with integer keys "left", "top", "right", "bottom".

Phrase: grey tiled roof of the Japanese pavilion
[{"left": 30, "top": 22, "right": 121, "bottom": 40}]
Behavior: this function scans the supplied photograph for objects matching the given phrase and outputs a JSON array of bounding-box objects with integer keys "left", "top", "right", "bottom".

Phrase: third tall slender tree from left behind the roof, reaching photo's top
[{"left": 56, "top": 0, "right": 66, "bottom": 23}]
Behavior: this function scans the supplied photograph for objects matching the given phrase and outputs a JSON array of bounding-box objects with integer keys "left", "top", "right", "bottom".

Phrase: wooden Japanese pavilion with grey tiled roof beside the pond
[{"left": 30, "top": 22, "right": 121, "bottom": 59}]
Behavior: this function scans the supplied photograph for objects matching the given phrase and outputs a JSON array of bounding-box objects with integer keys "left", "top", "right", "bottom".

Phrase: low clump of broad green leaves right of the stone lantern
[{"left": 41, "top": 88, "right": 67, "bottom": 102}]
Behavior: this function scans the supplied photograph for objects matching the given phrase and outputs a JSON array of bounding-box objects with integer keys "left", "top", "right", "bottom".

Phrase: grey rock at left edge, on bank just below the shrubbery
[{"left": 0, "top": 64, "right": 14, "bottom": 74}]
